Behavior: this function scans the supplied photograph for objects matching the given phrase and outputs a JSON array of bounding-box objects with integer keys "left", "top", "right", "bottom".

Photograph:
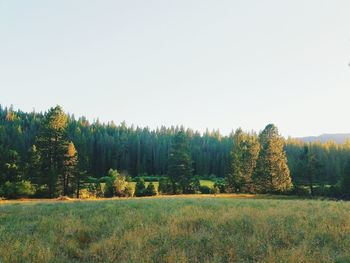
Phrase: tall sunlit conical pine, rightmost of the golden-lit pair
[{"left": 254, "top": 124, "right": 292, "bottom": 193}]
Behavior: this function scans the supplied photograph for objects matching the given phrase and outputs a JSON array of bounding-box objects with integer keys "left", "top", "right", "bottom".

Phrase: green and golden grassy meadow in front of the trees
[{"left": 0, "top": 195, "right": 350, "bottom": 262}]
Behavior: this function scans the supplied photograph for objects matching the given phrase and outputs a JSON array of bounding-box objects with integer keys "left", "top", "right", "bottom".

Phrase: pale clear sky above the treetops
[{"left": 0, "top": 0, "right": 350, "bottom": 136}]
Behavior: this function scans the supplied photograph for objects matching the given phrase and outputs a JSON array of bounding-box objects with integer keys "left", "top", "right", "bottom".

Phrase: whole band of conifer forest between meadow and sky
[{"left": 0, "top": 106, "right": 350, "bottom": 198}]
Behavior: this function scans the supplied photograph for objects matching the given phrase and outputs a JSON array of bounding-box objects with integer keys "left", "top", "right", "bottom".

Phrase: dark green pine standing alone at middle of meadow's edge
[{"left": 168, "top": 130, "right": 193, "bottom": 194}]
